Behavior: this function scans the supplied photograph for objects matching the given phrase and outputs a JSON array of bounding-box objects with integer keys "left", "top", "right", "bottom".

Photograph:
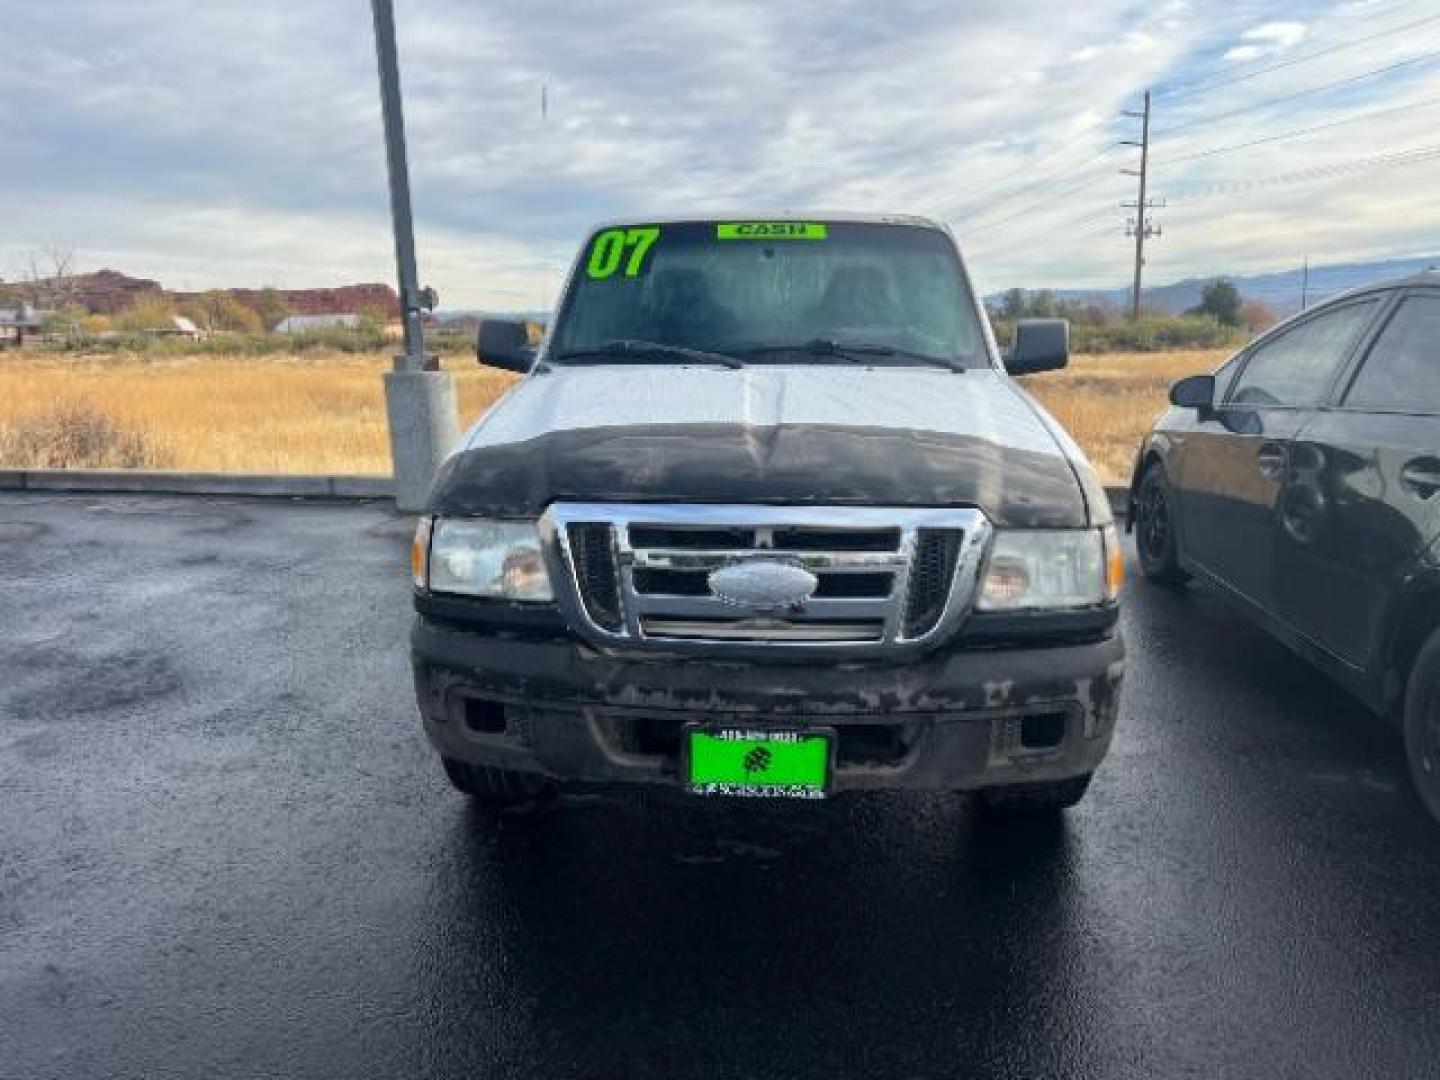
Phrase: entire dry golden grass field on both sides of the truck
[{"left": 0, "top": 351, "right": 1224, "bottom": 481}]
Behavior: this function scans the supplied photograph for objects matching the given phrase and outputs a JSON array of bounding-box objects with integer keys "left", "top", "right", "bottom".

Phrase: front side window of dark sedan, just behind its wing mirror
[{"left": 1228, "top": 300, "right": 1380, "bottom": 409}]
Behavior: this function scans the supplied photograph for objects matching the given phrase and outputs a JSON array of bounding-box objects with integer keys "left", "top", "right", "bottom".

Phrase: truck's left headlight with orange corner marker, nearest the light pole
[{"left": 413, "top": 517, "right": 554, "bottom": 602}]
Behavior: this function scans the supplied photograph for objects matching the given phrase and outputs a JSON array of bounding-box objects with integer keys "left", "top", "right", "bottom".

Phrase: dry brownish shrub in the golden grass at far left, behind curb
[{"left": 0, "top": 402, "right": 170, "bottom": 469}]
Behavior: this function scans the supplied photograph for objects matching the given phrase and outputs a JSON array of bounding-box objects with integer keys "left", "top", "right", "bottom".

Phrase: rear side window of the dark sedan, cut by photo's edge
[{"left": 1345, "top": 297, "right": 1440, "bottom": 415}]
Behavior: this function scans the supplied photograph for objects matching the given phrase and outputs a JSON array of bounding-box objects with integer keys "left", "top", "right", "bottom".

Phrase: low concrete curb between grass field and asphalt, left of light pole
[{"left": 0, "top": 469, "right": 395, "bottom": 500}]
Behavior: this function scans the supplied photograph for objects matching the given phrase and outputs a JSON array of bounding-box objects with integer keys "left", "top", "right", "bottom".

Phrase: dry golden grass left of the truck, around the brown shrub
[{"left": 0, "top": 353, "right": 513, "bottom": 474}]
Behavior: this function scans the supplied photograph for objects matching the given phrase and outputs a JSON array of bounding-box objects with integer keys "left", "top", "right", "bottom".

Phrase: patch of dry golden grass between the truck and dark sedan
[{"left": 1024, "top": 350, "right": 1228, "bottom": 484}]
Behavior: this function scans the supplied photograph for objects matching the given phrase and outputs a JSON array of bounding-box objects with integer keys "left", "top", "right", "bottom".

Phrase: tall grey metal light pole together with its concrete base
[{"left": 370, "top": 0, "right": 459, "bottom": 511}]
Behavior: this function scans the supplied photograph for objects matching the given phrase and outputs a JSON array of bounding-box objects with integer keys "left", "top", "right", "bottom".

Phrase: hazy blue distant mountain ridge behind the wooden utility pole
[{"left": 986, "top": 255, "right": 1440, "bottom": 317}]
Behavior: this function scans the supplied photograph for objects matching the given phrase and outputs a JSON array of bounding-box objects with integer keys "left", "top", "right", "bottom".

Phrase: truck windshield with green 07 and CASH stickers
[{"left": 550, "top": 222, "right": 984, "bottom": 366}]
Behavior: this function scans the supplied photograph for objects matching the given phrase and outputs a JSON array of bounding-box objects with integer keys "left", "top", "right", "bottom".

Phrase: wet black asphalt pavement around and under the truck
[{"left": 0, "top": 495, "right": 1440, "bottom": 1080}]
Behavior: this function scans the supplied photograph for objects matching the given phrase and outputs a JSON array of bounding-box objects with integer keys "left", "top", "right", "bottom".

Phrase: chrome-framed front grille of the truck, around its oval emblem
[{"left": 541, "top": 503, "right": 991, "bottom": 655}]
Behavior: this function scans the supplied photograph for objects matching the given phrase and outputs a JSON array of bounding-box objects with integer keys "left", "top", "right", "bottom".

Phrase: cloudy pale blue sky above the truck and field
[{"left": 0, "top": 0, "right": 1440, "bottom": 308}]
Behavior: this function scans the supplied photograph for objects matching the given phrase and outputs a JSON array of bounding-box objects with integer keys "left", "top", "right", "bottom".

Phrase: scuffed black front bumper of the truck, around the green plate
[{"left": 412, "top": 616, "right": 1125, "bottom": 791}]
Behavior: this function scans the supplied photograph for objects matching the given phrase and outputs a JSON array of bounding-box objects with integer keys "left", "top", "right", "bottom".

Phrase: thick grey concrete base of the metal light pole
[{"left": 384, "top": 372, "right": 459, "bottom": 514}]
